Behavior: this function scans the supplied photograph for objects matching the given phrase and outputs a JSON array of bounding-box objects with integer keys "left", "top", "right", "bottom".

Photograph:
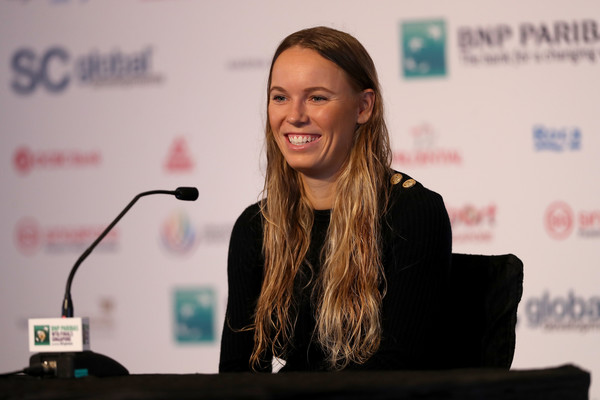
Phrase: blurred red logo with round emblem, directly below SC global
[{"left": 13, "top": 146, "right": 102, "bottom": 175}]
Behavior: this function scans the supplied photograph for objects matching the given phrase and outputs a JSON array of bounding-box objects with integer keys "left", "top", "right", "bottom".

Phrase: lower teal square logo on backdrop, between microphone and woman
[{"left": 174, "top": 287, "right": 216, "bottom": 344}]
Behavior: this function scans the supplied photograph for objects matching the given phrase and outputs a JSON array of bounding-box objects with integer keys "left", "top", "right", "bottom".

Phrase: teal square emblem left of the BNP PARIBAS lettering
[{"left": 401, "top": 20, "right": 446, "bottom": 78}]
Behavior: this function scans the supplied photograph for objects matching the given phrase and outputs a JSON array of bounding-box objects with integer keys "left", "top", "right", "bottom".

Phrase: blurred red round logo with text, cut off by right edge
[{"left": 544, "top": 201, "right": 600, "bottom": 240}]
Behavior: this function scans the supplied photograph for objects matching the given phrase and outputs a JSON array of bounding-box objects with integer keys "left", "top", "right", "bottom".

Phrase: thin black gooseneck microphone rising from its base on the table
[{"left": 62, "top": 186, "right": 198, "bottom": 318}]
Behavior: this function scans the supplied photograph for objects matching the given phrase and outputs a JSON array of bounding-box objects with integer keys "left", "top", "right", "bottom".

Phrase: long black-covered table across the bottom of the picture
[{"left": 0, "top": 365, "right": 590, "bottom": 400}]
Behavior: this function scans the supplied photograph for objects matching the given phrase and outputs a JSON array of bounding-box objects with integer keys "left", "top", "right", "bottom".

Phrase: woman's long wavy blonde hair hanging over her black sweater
[{"left": 250, "top": 27, "right": 391, "bottom": 369}]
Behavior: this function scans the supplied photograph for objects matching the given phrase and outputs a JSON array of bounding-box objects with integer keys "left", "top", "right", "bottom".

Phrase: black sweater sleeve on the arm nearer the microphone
[{"left": 219, "top": 204, "right": 271, "bottom": 372}]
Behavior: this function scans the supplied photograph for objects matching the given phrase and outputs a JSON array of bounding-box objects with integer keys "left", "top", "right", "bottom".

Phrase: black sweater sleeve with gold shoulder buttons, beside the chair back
[{"left": 361, "top": 181, "right": 452, "bottom": 369}]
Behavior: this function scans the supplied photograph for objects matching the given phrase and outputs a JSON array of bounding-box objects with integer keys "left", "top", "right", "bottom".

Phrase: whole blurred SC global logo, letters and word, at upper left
[{"left": 10, "top": 46, "right": 163, "bottom": 95}]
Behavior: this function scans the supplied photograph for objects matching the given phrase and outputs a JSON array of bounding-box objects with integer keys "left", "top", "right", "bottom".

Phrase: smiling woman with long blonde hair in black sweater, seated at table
[{"left": 219, "top": 27, "right": 451, "bottom": 372}]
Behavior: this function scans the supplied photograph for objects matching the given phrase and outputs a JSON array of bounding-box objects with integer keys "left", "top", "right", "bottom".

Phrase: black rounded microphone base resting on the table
[{"left": 29, "top": 350, "right": 129, "bottom": 378}]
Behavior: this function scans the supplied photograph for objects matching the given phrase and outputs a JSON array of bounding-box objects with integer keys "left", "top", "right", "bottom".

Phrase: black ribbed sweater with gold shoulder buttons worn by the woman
[{"left": 219, "top": 176, "right": 452, "bottom": 372}]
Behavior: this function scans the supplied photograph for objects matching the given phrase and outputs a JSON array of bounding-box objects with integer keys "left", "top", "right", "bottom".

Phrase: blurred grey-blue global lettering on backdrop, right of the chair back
[{"left": 525, "top": 290, "right": 600, "bottom": 332}]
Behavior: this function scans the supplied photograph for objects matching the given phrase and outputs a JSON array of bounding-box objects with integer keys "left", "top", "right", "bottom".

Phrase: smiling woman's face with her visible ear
[{"left": 268, "top": 46, "right": 374, "bottom": 180}]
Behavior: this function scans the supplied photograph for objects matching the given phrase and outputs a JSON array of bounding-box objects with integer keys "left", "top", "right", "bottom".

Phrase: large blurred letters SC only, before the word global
[{"left": 11, "top": 47, "right": 71, "bottom": 95}]
